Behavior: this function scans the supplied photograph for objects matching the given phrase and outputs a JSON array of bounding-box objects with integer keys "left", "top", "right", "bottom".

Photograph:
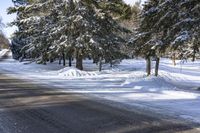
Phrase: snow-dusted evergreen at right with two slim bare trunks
[{"left": 132, "top": 0, "right": 200, "bottom": 76}]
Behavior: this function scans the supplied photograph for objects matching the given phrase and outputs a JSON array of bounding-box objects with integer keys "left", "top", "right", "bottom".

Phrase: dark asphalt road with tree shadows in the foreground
[{"left": 0, "top": 74, "right": 200, "bottom": 133}]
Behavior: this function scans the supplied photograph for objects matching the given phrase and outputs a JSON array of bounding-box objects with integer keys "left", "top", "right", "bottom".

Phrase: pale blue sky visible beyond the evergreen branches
[{"left": 0, "top": 0, "right": 144, "bottom": 38}]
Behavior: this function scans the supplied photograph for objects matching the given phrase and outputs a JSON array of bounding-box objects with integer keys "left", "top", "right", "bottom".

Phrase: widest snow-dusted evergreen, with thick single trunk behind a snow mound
[{"left": 10, "top": 0, "right": 128, "bottom": 69}]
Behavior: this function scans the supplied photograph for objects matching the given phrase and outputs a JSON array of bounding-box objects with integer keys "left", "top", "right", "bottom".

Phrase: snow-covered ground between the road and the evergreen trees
[{"left": 0, "top": 52, "right": 200, "bottom": 123}]
